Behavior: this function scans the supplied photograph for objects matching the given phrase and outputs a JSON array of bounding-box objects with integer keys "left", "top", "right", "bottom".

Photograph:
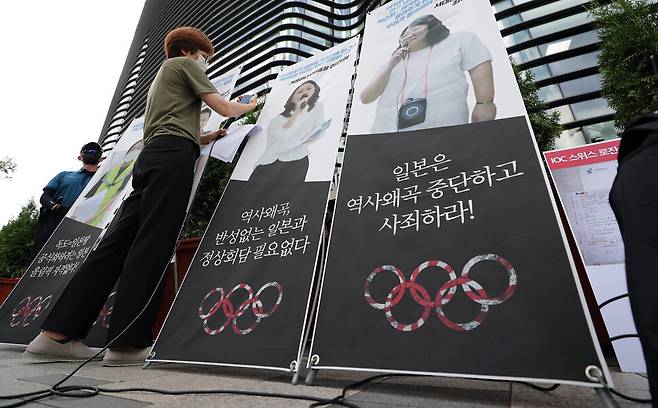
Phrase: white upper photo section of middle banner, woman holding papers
[{"left": 231, "top": 39, "right": 357, "bottom": 183}]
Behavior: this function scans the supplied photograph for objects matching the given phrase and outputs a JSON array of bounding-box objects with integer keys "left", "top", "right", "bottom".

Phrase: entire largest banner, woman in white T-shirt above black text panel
[{"left": 308, "top": 0, "right": 609, "bottom": 385}]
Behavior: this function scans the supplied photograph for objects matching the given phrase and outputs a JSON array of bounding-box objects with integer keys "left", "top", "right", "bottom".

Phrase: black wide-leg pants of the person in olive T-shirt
[{"left": 42, "top": 136, "right": 199, "bottom": 347}]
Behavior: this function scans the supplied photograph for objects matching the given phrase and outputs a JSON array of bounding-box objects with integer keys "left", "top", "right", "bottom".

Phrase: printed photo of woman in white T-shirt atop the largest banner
[{"left": 349, "top": 0, "right": 525, "bottom": 134}]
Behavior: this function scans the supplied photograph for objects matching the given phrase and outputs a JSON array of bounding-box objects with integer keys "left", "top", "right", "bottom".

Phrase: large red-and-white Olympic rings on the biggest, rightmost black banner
[{"left": 364, "top": 254, "right": 518, "bottom": 332}]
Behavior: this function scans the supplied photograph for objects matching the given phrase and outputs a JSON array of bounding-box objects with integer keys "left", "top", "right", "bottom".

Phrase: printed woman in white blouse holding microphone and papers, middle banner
[{"left": 249, "top": 80, "right": 330, "bottom": 183}]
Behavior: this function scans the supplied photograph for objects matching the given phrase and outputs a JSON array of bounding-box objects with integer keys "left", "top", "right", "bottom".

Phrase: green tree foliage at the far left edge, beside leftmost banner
[{"left": 0, "top": 200, "right": 39, "bottom": 278}]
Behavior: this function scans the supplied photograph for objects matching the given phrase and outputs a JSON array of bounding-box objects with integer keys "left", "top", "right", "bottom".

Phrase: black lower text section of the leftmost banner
[{"left": 0, "top": 217, "right": 102, "bottom": 344}]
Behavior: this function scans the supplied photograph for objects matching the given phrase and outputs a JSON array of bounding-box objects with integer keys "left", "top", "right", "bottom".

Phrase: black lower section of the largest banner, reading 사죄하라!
[{"left": 312, "top": 117, "right": 602, "bottom": 382}]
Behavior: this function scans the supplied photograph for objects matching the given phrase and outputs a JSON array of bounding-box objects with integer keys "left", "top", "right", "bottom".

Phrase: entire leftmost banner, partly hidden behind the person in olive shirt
[{"left": 0, "top": 119, "right": 144, "bottom": 344}]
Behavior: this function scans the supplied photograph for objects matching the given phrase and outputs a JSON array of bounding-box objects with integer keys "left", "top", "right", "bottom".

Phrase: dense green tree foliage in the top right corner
[{"left": 590, "top": 0, "right": 658, "bottom": 130}]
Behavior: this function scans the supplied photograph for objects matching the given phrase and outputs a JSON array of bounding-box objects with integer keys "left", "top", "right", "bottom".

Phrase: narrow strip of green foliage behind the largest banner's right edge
[{"left": 512, "top": 61, "right": 562, "bottom": 152}]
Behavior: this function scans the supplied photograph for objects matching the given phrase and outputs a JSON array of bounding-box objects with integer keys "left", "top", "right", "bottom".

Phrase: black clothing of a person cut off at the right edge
[{"left": 610, "top": 144, "right": 658, "bottom": 407}]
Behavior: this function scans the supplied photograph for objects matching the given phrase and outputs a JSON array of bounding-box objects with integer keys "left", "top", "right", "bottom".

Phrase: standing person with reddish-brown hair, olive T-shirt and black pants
[{"left": 25, "top": 27, "right": 256, "bottom": 366}]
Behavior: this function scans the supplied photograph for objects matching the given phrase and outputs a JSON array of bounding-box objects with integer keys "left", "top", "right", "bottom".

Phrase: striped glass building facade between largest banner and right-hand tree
[{"left": 492, "top": 0, "right": 617, "bottom": 148}]
